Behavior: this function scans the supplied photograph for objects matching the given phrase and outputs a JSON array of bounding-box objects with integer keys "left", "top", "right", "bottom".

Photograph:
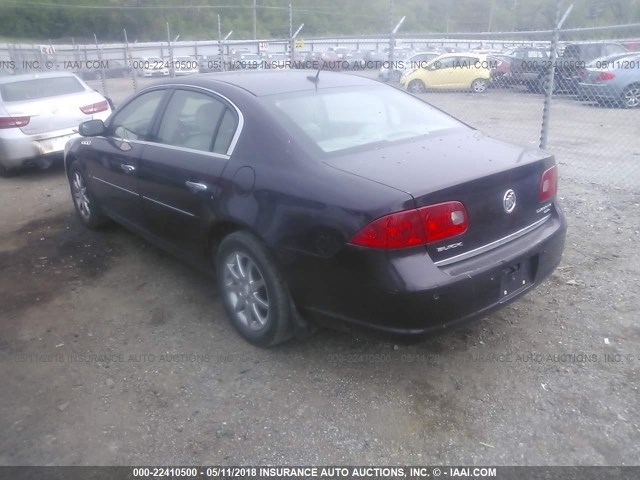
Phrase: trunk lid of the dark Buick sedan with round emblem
[{"left": 326, "top": 130, "right": 555, "bottom": 263}]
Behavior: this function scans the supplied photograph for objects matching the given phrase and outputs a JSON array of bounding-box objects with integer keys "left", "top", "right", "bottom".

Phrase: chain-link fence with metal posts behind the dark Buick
[{"left": 0, "top": 24, "right": 640, "bottom": 188}]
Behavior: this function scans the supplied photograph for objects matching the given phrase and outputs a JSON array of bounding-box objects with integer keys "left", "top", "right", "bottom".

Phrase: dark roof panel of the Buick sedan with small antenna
[{"left": 151, "top": 70, "right": 380, "bottom": 97}]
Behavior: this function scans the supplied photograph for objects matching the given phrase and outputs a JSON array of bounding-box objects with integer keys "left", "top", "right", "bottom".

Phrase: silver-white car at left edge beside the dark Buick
[{"left": 0, "top": 72, "right": 111, "bottom": 175}]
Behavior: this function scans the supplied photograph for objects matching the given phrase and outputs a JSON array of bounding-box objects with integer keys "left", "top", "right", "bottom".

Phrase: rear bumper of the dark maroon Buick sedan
[{"left": 289, "top": 204, "right": 566, "bottom": 335}]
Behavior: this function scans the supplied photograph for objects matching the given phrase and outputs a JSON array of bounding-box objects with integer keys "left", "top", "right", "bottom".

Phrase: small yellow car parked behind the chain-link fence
[{"left": 400, "top": 53, "right": 492, "bottom": 93}]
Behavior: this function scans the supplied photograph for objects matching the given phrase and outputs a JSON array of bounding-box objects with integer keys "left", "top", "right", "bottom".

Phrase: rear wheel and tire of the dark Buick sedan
[{"left": 215, "top": 231, "right": 293, "bottom": 347}]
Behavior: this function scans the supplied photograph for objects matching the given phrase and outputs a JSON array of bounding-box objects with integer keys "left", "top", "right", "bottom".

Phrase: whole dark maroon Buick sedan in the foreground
[{"left": 65, "top": 70, "right": 566, "bottom": 346}]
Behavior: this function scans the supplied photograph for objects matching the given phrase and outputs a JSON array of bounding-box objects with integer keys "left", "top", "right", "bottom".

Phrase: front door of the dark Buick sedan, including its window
[{"left": 83, "top": 89, "right": 167, "bottom": 223}]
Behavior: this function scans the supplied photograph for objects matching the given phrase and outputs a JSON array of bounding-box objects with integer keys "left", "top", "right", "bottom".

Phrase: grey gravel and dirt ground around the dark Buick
[{"left": 0, "top": 74, "right": 640, "bottom": 465}]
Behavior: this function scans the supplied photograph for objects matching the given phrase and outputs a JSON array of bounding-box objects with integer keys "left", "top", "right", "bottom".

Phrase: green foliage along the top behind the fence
[{"left": 0, "top": 0, "right": 640, "bottom": 41}]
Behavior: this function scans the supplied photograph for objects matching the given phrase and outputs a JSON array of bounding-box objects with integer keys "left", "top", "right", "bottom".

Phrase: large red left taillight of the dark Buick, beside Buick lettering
[{"left": 350, "top": 202, "right": 469, "bottom": 248}]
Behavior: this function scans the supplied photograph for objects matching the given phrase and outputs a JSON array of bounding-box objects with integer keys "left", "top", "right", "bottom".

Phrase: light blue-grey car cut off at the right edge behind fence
[{"left": 578, "top": 52, "right": 640, "bottom": 108}]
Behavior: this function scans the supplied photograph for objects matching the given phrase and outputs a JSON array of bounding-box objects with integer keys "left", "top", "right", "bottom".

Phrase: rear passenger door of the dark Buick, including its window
[{"left": 140, "top": 87, "right": 239, "bottom": 255}]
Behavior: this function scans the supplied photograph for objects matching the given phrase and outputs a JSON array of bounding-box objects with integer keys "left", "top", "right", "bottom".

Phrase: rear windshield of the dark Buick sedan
[{"left": 264, "top": 86, "right": 463, "bottom": 153}]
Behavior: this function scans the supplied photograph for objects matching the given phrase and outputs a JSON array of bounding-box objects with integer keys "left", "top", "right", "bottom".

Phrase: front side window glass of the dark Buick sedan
[{"left": 111, "top": 90, "right": 166, "bottom": 140}]
